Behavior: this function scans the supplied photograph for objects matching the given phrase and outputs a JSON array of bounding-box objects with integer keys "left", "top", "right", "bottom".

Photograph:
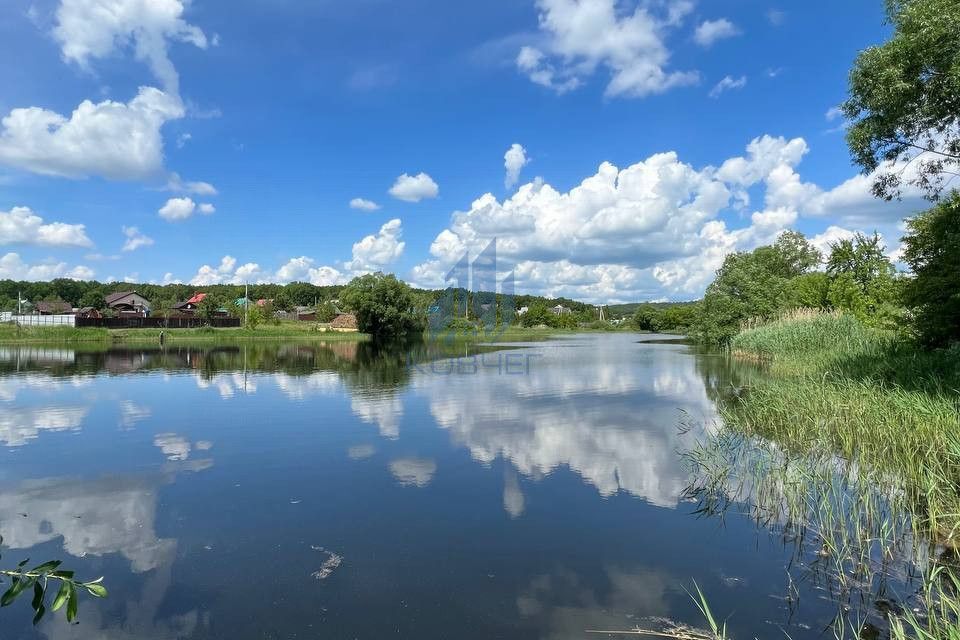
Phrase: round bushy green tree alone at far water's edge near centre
[{"left": 340, "top": 272, "right": 425, "bottom": 338}]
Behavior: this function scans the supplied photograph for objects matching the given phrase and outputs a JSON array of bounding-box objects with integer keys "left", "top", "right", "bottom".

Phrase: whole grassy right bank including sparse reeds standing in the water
[{"left": 694, "top": 312, "right": 960, "bottom": 638}]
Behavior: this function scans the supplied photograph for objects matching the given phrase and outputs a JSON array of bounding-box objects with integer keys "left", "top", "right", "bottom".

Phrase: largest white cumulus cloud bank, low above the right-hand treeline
[{"left": 411, "top": 136, "right": 909, "bottom": 302}]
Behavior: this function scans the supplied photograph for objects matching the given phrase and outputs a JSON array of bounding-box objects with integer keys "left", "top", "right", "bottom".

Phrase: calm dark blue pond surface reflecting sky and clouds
[{"left": 0, "top": 334, "right": 868, "bottom": 640}]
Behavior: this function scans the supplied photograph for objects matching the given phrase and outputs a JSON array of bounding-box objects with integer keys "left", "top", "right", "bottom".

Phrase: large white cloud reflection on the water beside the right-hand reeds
[{"left": 413, "top": 335, "right": 716, "bottom": 511}]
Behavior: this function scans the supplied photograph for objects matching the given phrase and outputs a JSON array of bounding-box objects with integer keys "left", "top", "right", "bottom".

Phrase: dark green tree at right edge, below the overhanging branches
[{"left": 903, "top": 192, "right": 960, "bottom": 346}]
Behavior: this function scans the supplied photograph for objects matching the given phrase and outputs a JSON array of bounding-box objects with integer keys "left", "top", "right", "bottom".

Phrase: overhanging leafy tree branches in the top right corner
[{"left": 843, "top": 0, "right": 960, "bottom": 200}]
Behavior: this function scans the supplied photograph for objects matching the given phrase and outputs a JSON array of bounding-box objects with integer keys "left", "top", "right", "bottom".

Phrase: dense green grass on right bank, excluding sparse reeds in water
[{"left": 725, "top": 313, "right": 960, "bottom": 528}]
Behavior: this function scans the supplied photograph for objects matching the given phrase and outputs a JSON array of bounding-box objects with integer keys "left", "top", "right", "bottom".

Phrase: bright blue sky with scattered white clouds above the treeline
[{"left": 0, "top": 0, "right": 922, "bottom": 302}]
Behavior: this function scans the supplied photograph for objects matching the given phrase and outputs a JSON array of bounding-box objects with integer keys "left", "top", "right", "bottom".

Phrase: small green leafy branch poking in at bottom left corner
[{"left": 0, "top": 536, "right": 107, "bottom": 624}]
